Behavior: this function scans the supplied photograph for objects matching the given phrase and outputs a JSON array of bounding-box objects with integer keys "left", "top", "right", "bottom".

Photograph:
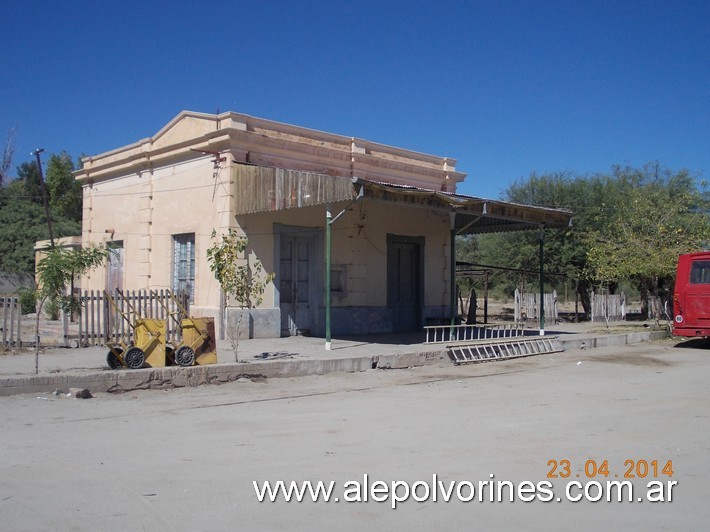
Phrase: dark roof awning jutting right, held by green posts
[{"left": 353, "top": 178, "right": 572, "bottom": 234}]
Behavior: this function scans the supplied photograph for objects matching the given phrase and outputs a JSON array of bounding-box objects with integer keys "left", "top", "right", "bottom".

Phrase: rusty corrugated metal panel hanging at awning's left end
[{"left": 233, "top": 164, "right": 354, "bottom": 215}]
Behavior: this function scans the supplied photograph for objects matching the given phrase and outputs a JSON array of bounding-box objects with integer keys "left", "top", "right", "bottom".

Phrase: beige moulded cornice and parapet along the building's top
[{"left": 75, "top": 111, "right": 466, "bottom": 191}]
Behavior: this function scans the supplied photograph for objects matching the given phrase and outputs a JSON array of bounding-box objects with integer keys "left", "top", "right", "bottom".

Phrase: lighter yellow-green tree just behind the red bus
[{"left": 586, "top": 164, "right": 710, "bottom": 316}]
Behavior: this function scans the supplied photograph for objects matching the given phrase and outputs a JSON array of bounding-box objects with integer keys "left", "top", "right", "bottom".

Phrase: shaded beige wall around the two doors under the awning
[{"left": 237, "top": 200, "right": 450, "bottom": 307}]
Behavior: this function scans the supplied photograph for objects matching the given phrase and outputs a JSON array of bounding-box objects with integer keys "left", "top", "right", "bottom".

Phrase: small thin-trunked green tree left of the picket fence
[{"left": 34, "top": 245, "right": 110, "bottom": 373}]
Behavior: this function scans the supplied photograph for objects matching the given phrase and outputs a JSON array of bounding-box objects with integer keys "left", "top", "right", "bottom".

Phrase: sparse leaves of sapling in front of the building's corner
[{"left": 207, "top": 227, "right": 274, "bottom": 308}]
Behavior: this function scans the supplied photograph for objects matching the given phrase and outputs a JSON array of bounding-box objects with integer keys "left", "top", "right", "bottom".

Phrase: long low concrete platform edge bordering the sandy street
[{"left": 0, "top": 331, "right": 668, "bottom": 396}]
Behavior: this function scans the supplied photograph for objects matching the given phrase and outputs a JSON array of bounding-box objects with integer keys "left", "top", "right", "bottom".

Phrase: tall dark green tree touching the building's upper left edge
[{"left": 46, "top": 151, "right": 82, "bottom": 222}]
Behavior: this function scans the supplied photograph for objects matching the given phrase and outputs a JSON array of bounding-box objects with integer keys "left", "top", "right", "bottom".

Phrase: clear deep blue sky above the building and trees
[{"left": 0, "top": 0, "right": 710, "bottom": 199}]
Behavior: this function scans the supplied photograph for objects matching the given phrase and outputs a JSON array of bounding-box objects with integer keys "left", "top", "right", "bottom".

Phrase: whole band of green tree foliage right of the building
[{"left": 459, "top": 164, "right": 710, "bottom": 310}]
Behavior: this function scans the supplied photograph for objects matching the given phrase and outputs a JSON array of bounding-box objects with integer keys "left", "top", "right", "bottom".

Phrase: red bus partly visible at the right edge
[{"left": 673, "top": 251, "right": 710, "bottom": 337}]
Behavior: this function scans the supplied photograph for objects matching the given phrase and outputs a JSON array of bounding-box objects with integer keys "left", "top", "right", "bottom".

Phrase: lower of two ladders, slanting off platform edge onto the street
[{"left": 447, "top": 337, "right": 562, "bottom": 364}]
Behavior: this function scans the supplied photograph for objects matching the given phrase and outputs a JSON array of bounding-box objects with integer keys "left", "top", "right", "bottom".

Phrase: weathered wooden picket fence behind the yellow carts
[{"left": 76, "top": 290, "right": 190, "bottom": 347}]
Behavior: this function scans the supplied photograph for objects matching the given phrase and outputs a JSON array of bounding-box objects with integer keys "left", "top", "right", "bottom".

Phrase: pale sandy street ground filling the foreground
[{"left": 0, "top": 340, "right": 710, "bottom": 530}]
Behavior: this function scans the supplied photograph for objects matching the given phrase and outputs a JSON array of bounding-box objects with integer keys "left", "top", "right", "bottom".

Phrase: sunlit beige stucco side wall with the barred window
[{"left": 82, "top": 153, "right": 233, "bottom": 316}]
